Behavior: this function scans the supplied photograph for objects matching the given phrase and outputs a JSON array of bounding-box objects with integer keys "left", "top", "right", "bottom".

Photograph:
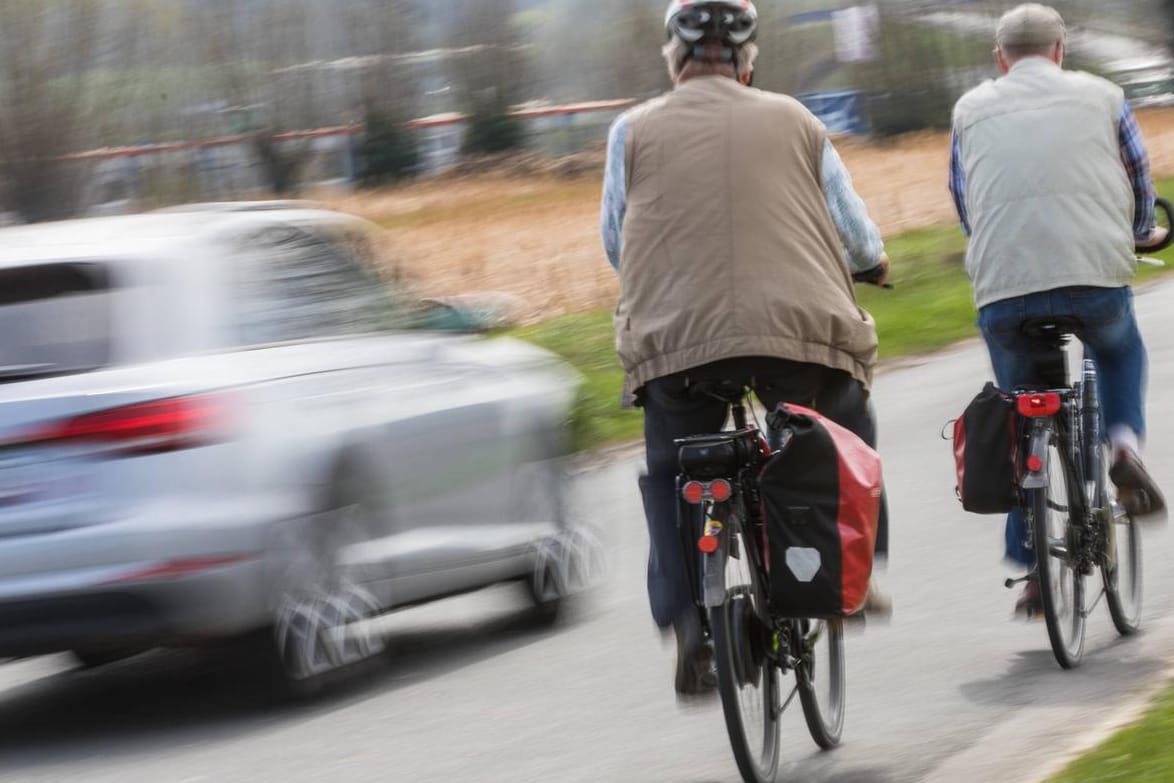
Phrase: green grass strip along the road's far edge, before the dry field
[{"left": 510, "top": 180, "right": 1174, "bottom": 450}]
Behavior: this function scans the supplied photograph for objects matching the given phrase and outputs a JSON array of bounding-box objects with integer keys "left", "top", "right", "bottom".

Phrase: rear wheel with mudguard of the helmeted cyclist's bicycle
[{"left": 710, "top": 520, "right": 783, "bottom": 783}]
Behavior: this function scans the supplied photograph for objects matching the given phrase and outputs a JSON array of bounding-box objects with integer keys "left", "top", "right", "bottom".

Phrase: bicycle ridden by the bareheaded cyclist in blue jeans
[{"left": 1006, "top": 200, "right": 1174, "bottom": 669}]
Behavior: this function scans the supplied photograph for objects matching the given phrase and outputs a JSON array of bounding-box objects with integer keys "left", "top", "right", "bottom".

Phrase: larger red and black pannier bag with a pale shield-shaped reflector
[{"left": 758, "top": 404, "right": 883, "bottom": 617}]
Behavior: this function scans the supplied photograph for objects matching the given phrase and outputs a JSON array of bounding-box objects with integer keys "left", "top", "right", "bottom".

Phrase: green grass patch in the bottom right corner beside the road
[{"left": 1050, "top": 690, "right": 1174, "bottom": 783}]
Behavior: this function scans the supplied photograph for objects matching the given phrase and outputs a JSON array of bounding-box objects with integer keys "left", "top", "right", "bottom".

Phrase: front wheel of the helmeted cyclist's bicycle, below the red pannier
[{"left": 795, "top": 619, "right": 846, "bottom": 750}]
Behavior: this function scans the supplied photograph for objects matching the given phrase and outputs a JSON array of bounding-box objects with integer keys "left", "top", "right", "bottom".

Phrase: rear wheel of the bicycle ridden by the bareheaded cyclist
[{"left": 1027, "top": 433, "right": 1085, "bottom": 669}]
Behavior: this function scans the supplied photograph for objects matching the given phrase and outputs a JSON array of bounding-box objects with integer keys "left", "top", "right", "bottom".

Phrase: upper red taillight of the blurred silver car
[{"left": 20, "top": 394, "right": 225, "bottom": 454}]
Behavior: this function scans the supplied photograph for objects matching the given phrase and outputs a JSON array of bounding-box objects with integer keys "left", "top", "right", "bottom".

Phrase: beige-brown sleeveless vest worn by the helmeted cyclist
[{"left": 615, "top": 76, "right": 877, "bottom": 392}]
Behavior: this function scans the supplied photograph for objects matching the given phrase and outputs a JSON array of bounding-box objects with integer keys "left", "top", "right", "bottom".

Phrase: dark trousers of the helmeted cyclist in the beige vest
[{"left": 640, "top": 357, "right": 889, "bottom": 628}]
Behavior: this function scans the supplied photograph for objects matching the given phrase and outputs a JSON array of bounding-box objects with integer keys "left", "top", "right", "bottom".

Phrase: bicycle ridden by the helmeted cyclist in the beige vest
[{"left": 675, "top": 270, "right": 891, "bottom": 783}]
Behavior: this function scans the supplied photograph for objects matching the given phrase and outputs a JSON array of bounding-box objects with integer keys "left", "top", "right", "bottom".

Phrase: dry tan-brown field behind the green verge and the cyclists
[{"left": 322, "top": 109, "right": 1174, "bottom": 322}]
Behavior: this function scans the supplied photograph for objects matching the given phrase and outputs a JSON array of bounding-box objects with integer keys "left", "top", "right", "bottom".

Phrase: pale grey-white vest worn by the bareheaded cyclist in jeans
[{"left": 953, "top": 58, "right": 1136, "bottom": 308}]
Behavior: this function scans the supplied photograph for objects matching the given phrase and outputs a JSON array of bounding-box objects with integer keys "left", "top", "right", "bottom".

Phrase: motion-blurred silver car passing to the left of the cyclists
[{"left": 0, "top": 204, "right": 587, "bottom": 681}]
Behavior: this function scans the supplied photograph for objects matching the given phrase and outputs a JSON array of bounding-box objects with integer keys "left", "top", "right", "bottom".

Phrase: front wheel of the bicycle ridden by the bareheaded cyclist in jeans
[{"left": 1100, "top": 448, "right": 1142, "bottom": 636}]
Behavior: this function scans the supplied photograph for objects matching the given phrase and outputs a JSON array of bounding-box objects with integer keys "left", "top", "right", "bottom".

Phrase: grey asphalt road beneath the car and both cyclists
[{"left": 0, "top": 285, "right": 1174, "bottom": 783}]
